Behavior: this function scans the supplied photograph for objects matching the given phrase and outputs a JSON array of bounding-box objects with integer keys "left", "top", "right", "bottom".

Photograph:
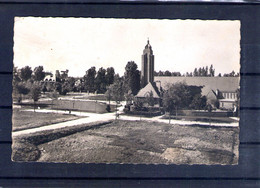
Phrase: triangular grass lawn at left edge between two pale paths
[{"left": 13, "top": 109, "right": 81, "bottom": 131}]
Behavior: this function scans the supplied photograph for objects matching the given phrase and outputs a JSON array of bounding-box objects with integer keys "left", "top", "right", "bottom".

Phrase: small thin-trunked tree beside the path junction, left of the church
[{"left": 107, "top": 79, "right": 124, "bottom": 119}]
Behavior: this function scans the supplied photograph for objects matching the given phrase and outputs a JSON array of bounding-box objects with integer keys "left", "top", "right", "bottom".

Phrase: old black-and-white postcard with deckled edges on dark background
[{"left": 12, "top": 17, "right": 241, "bottom": 165}]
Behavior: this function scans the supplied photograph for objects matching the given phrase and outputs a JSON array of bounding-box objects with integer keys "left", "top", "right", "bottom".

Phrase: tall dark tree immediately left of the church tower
[{"left": 124, "top": 61, "right": 140, "bottom": 95}]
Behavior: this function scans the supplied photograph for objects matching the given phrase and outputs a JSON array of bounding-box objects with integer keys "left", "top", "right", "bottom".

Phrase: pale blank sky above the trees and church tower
[{"left": 14, "top": 17, "right": 240, "bottom": 77}]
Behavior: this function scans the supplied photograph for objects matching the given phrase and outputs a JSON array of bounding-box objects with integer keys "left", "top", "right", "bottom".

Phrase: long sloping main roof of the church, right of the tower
[{"left": 154, "top": 76, "right": 240, "bottom": 95}]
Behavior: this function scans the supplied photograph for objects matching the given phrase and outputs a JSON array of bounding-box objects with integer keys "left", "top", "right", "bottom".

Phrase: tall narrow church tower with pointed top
[{"left": 141, "top": 39, "right": 154, "bottom": 88}]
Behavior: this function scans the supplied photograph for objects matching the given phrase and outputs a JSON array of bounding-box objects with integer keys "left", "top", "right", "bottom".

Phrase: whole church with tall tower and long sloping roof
[{"left": 135, "top": 39, "right": 240, "bottom": 109}]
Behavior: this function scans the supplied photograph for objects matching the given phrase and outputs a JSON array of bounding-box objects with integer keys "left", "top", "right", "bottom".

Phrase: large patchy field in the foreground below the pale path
[{"left": 37, "top": 120, "right": 239, "bottom": 165}]
